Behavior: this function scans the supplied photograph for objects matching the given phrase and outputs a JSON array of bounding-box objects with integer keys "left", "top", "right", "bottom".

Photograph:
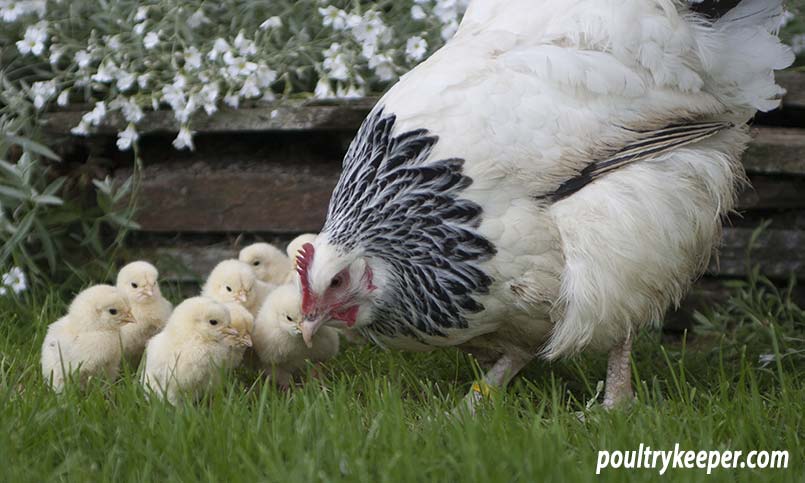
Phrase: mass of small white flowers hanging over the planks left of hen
[{"left": 0, "top": 0, "right": 468, "bottom": 150}]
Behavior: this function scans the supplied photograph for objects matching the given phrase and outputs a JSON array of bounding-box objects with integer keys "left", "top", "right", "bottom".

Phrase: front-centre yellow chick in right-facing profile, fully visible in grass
[{"left": 142, "top": 297, "right": 238, "bottom": 405}]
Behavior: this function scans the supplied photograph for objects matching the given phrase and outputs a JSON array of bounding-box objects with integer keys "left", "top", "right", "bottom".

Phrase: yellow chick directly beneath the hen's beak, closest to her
[{"left": 252, "top": 284, "right": 338, "bottom": 387}]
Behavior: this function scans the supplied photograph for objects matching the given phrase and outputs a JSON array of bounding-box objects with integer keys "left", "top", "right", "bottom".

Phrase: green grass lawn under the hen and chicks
[{"left": 0, "top": 279, "right": 805, "bottom": 483}]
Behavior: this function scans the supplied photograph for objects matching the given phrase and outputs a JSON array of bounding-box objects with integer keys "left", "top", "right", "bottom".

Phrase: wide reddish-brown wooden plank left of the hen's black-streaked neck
[{"left": 116, "top": 160, "right": 341, "bottom": 233}]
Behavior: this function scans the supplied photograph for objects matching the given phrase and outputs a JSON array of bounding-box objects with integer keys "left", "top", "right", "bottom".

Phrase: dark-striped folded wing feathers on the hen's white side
[{"left": 538, "top": 122, "right": 734, "bottom": 202}]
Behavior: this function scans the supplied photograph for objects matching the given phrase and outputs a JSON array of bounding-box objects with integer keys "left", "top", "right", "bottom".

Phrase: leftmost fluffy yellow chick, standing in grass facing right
[{"left": 42, "top": 285, "right": 134, "bottom": 392}]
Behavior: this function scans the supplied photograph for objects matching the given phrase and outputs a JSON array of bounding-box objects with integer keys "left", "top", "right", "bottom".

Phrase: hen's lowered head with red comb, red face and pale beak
[{"left": 296, "top": 237, "right": 377, "bottom": 345}]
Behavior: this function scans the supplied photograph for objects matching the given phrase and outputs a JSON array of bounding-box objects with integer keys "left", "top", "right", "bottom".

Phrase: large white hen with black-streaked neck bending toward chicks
[{"left": 290, "top": 0, "right": 793, "bottom": 412}]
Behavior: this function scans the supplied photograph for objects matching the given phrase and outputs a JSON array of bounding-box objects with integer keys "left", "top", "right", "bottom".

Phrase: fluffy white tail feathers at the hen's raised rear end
[{"left": 692, "top": 0, "right": 795, "bottom": 112}]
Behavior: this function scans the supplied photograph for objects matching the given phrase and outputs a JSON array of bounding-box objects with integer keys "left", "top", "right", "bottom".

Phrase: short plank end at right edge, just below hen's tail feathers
[{"left": 743, "top": 126, "right": 805, "bottom": 176}]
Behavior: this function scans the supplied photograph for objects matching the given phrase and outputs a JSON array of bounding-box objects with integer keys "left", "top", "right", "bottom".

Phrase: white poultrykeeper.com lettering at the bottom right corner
[{"left": 595, "top": 443, "right": 788, "bottom": 475}]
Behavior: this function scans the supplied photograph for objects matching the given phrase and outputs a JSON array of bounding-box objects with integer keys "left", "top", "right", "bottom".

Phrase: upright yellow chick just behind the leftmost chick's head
[{"left": 117, "top": 261, "right": 173, "bottom": 365}]
